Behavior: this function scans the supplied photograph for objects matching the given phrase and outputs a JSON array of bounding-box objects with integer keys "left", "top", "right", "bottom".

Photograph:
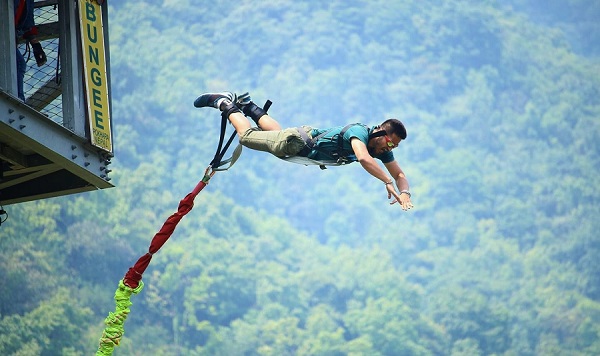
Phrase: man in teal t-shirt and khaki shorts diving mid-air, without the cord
[{"left": 194, "top": 92, "right": 413, "bottom": 210}]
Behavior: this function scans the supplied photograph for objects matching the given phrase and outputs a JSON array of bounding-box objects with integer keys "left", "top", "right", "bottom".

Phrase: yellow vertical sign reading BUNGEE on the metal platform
[{"left": 79, "top": 0, "right": 113, "bottom": 153}]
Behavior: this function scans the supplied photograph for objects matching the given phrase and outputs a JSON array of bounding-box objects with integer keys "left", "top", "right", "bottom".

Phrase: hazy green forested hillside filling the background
[{"left": 0, "top": 0, "right": 600, "bottom": 356}]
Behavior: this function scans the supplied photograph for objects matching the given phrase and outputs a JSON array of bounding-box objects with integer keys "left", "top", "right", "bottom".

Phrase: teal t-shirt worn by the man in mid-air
[{"left": 308, "top": 124, "right": 394, "bottom": 163}]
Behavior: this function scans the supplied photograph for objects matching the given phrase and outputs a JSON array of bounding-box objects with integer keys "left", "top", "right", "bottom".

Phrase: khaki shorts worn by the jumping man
[{"left": 240, "top": 126, "right": 312, "bottom": 157}]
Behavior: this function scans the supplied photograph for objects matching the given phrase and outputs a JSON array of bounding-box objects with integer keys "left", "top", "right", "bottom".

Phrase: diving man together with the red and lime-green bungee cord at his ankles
[{"left": 96, "top": 92, "right": 413, "bottom": 356}]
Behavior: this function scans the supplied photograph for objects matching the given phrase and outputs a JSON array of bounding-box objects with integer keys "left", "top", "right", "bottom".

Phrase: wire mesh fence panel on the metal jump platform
[{"left": 18, "top": 3, "right": 63, "bottom": 125}]
